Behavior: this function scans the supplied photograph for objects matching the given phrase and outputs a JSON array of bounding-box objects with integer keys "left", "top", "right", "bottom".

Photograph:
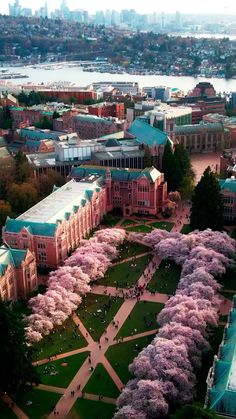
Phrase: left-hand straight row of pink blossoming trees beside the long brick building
[{"left": 25, "top": 228, "right": 125, "bottom": 342}]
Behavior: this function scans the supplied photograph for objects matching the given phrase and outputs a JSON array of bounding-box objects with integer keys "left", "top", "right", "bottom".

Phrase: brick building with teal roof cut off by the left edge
[{"left": 0, "top": 246, "right": 38, "bottom": 301}]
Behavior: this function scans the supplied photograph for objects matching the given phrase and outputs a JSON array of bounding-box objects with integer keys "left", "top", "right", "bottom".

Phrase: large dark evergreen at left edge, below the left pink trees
[{"left": 0, "top": 302, "right": 39, "bottom": 392}]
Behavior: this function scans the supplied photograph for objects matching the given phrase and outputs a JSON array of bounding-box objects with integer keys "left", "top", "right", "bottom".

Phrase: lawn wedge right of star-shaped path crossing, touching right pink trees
[{"left": 106, "top": 335, "right": 155, "bottom": 384}]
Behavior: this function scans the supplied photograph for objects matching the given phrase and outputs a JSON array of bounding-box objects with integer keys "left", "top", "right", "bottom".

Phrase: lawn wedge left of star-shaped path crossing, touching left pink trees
[{"left": 34, "top": 317, "right": 87, "bottom": 360}]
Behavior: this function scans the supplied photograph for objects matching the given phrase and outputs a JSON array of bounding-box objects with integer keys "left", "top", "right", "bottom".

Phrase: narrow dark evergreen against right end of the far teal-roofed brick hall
[{"left": 162, "top": 141, "right": 182, "bottom": 191}]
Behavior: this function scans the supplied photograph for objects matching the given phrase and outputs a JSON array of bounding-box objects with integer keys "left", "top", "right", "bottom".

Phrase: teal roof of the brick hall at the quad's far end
[{"left": 70, "top": 165, "right": 161, "bottom": 182}]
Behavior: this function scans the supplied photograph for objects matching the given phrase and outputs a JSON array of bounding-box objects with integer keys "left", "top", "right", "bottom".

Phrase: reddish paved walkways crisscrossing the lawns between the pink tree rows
[{"left": 7, "top": 205, "right": 232, "bottom": 419}]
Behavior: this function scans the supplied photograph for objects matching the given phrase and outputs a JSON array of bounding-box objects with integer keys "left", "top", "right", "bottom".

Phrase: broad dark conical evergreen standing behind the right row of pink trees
[{"left": 190, "top": 167, "right": 223, "bottom": 230}]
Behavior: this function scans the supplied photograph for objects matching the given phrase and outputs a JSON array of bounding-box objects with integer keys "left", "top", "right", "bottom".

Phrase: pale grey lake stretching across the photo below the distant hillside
[{"left": 1, "top": 63, "right": 236, "bottom": 92}]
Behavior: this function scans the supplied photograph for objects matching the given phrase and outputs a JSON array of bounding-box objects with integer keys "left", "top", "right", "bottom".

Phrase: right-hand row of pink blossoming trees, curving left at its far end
[{"left": 114, "top": 229, "right": 235, "bottom": 419}]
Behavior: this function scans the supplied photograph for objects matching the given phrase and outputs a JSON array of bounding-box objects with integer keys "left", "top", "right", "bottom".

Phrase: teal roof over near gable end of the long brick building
[{"left": 5, "top": 218, "right": 57, "bottom": 237}]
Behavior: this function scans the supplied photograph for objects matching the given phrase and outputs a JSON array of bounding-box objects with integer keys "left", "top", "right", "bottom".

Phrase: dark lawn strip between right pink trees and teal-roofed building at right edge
[{"left": 195, "top": 326, "right": 224, "bottom": 403}]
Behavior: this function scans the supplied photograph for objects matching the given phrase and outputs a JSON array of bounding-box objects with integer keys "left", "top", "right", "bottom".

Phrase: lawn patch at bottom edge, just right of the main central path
[{"left": 67, "top": 399, "right": 116, "bottom": 419}]
